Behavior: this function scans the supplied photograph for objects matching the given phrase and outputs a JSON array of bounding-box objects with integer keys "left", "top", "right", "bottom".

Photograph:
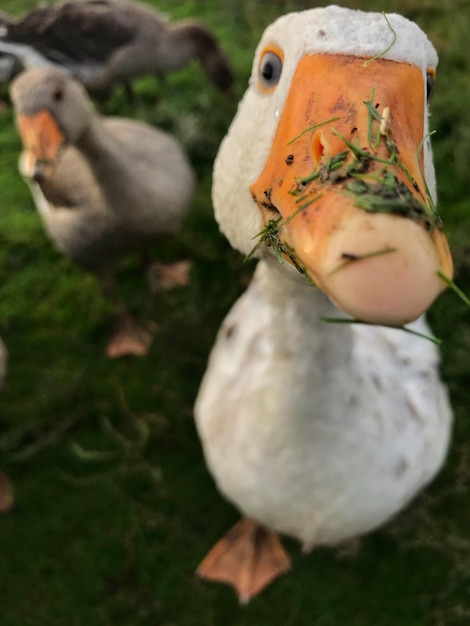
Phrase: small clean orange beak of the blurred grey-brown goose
[{"left": 16, "top": 111, "right": 65, "bottom": 163}]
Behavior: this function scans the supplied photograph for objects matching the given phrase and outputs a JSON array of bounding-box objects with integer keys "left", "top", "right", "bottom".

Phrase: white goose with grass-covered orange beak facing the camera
[{"left": 195, "top": 6, "right": 452, "bottom": 601}]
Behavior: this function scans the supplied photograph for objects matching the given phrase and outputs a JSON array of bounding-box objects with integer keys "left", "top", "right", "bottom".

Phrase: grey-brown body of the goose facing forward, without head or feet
[{"left": 20, "top": 118, "right": 193, "bottom": 273}]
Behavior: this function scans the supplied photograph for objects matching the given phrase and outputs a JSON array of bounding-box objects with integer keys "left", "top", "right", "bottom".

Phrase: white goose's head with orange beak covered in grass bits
[{"left": 213, "top": 6, "right": 452, "bottom": 325}]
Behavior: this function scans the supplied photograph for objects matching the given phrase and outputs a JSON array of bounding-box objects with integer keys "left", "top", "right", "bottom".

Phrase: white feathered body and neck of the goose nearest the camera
[{"left": 196, "top": 261, "right": 451, "bottom": 545}]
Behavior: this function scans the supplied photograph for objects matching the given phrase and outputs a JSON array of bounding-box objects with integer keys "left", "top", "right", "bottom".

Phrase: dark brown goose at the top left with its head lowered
[{"left": 0, "top": 0, "right": 233, "bottom": 96}]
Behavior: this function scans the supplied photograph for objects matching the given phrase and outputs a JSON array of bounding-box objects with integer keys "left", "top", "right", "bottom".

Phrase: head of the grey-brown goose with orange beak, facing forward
[{"left": 10, "top": 68, "right": 94, "bottom": 163}]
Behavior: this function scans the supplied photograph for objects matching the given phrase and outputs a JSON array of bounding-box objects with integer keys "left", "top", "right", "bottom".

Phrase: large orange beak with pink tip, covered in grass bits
[{"left": 251, "top": 54, "right": 452, "bottom": 325}]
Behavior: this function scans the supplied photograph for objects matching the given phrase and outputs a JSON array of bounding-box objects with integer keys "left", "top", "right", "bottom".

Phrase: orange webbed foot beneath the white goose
[{"left": 196, "top": 519, "right": 291, "bottom": 604}]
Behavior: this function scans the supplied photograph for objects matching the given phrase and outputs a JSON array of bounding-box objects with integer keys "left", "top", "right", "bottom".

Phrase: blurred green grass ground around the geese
[{"left": 0, "top": 0, "right": 470, "bottom": 626}]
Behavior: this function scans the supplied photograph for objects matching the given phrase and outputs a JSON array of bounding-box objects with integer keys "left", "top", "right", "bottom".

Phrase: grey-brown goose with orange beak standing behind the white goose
[{"left": 10, "top": 68, "right": 194, "bottom": 357}]
